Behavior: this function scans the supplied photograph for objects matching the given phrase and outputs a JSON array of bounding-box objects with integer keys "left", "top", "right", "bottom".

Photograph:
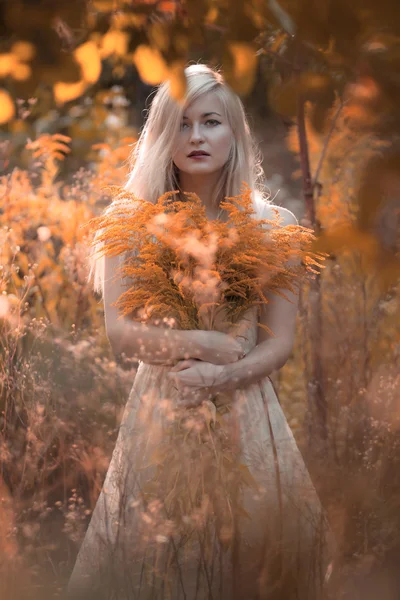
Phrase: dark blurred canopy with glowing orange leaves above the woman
[{"left": 0, "top": 0, "right": 400, "bottom": 264}]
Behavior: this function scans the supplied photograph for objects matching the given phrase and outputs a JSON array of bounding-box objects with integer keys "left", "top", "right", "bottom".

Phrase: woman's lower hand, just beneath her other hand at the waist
[{"left": 168, "top": 359, "right": 227, "bottom": 405}]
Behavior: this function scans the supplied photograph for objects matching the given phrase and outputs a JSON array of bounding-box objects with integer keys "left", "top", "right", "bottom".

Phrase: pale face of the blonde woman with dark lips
[{"left": 172, "top": 92, "right": 234, "bottom": 175}]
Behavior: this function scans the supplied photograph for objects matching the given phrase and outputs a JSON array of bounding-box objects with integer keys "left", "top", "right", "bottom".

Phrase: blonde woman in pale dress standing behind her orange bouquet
[{"left": 69, "top": 65, "right": 327, "bottom": 600}]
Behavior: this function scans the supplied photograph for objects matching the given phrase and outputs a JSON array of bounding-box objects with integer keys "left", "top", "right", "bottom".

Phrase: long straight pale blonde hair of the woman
[{"left": 88, "top": 64, "right": 264, "bottom": 294}]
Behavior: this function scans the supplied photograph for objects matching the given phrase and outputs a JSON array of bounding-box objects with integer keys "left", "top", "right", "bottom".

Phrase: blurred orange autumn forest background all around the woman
[{"left": 0, "top": 0, "right": 400, "bottom": 600}]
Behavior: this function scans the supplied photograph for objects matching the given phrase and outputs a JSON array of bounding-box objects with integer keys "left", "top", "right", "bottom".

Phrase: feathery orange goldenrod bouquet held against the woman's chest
[{"left": 89, "top": 187, "right": 322, "bottom": 329}]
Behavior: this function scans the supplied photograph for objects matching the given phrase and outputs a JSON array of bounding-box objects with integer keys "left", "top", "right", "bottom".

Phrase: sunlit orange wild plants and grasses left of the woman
[{"left": 0, "top": 134, "right": 135, "bottom": 598}]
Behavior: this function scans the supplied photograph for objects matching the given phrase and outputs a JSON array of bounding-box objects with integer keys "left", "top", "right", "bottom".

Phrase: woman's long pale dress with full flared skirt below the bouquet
[{"left": 68, "top": 198, "right": 330, "bottom": 600}]
